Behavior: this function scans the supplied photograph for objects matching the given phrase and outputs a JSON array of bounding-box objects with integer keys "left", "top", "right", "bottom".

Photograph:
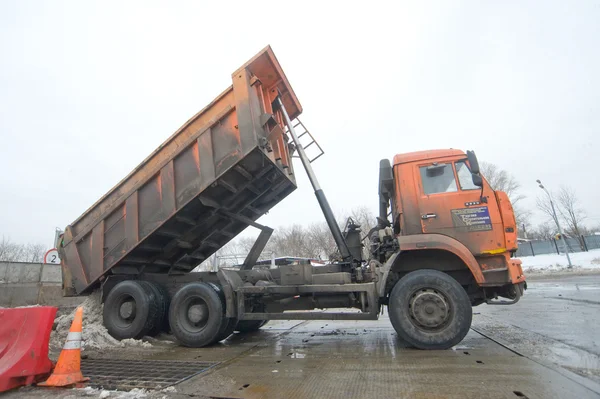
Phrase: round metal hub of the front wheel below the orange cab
[{"left": 409, "top": 289, "right": 450, "bottom": 329}]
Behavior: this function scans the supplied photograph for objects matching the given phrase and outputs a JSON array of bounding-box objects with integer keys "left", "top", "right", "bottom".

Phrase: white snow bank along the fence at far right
[{"left": 520, "top": 249, "right": 600, "bottom": 275}]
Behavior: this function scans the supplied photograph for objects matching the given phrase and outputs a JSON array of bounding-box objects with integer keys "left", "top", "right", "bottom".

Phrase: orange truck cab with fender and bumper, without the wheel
[{"left": 380, "top": 149, "right": 526, "bottom": 305}]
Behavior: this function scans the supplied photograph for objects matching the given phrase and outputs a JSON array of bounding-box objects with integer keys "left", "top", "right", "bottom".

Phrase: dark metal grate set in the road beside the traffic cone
[{"left": 81, "top": 359, "right": 218, "bottom": 391}]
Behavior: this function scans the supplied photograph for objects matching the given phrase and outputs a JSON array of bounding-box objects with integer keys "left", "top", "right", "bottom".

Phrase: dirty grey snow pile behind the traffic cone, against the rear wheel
[{"left": 50, "top": 290, "right": 152, "bottom": 350}]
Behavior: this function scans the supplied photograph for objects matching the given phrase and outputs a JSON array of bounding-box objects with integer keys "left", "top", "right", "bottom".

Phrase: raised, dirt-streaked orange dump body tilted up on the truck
[{"left": 59, "top": 47, "right": 302, "bottom": 296}]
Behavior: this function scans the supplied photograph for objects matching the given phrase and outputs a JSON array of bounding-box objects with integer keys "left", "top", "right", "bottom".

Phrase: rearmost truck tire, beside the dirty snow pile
[{"left": 102, "top": 280, "right": 159, "bottom": 340}]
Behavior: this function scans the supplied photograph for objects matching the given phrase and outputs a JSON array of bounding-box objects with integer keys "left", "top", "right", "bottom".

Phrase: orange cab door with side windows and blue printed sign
[{"left": 414, "top": 160, "right": 505, "bottom": 255}]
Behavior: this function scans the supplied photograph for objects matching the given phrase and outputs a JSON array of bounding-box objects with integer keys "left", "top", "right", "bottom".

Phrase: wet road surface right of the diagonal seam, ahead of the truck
[{"left": 473, "top": 275, "right": 600, "bottom": 392}]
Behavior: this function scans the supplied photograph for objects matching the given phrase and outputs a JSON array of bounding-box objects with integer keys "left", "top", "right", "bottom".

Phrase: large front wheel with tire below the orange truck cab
[{"left": 388, "top": 270, "right": 473, "bottom": 349}]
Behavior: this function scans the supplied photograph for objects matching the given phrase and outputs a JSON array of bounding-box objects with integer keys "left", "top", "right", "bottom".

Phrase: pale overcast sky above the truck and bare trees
[{"left": 0, "top": 0, "right": 600, "bottom": 245}]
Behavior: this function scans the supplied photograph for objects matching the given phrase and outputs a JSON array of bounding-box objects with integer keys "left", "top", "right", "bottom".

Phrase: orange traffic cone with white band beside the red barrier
[{"left": 38, "top": 306, "right": 89, "bottom": 387}]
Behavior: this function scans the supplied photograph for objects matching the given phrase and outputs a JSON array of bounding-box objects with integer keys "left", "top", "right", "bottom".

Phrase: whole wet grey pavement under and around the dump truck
[{"left": 5, "top": 276, "right": 600, "bottom": 399}]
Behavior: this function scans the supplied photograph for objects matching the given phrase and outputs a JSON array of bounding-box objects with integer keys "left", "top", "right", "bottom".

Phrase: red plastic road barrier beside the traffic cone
[{"left": 0, "top": 306, "right": 58, "bottom": 392}]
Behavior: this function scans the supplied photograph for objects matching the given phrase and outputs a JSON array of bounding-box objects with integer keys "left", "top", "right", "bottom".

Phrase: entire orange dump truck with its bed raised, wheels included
[{"left": 58, "top": 47, "right": 526, "bottom": 349}]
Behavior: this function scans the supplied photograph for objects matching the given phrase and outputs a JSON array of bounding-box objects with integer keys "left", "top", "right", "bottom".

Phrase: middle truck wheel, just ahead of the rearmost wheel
[{"left": 169, "top": 283, "right": 227, "bottom": 348}]
